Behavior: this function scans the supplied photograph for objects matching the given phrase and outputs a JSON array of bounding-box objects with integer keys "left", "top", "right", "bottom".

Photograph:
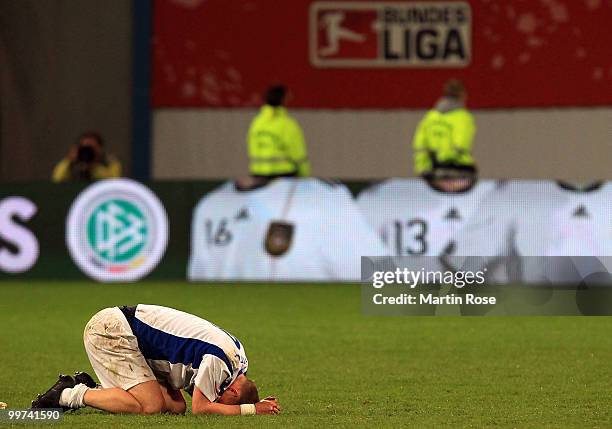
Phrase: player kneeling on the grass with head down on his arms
[{"left": 32, "top": 304, "right": 280, "bottom": 415}]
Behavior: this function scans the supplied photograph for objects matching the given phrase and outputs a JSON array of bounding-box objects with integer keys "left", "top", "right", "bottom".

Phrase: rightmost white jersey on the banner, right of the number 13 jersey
[{"left": 456, "top": 181, "right": 612, "bottom": 283}]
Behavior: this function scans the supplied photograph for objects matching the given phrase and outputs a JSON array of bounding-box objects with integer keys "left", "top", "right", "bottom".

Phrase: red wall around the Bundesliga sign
[{"left": 153, "top": 0, "right": 612, "bottom": 109}]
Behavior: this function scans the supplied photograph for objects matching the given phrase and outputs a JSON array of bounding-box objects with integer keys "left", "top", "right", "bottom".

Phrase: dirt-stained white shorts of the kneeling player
[{"left": 83, "top": 307, "right": 156, "bottom": 390}]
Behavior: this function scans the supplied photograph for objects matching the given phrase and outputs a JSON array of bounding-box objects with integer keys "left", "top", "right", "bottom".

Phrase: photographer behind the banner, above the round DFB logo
[{"left": 52, "top": 132, "right": 121, "bottom": 183}]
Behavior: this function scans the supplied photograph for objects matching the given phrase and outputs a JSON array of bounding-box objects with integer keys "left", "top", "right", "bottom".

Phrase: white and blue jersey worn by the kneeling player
[{"left": 122, "top": 304, "right": 249, "bottom": 402}]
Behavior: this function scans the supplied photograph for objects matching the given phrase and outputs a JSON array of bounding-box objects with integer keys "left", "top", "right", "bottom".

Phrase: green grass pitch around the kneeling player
[{"left": 0, "top": 282, "right": 612, "bottom": 428}]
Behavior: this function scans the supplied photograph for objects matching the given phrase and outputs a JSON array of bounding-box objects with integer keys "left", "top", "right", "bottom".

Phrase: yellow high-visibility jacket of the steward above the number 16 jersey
[{"left": 247, "top": 105, "right": 310, "bottom": 176}]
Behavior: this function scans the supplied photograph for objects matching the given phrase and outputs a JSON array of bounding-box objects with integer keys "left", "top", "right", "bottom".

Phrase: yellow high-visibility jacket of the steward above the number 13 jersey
[{"left": 413, "top": 108, "right": 476, "bottom": 175}]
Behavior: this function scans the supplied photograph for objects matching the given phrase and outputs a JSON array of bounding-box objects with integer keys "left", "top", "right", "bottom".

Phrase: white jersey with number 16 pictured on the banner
[{"left": 188, "top": 178, "right": 387, "bottom": 281}]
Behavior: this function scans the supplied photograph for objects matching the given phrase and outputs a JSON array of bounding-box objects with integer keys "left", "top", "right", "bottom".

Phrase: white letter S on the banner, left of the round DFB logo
[{"left": 0, "top": 197, "right": 39, "bottom": 274}]
